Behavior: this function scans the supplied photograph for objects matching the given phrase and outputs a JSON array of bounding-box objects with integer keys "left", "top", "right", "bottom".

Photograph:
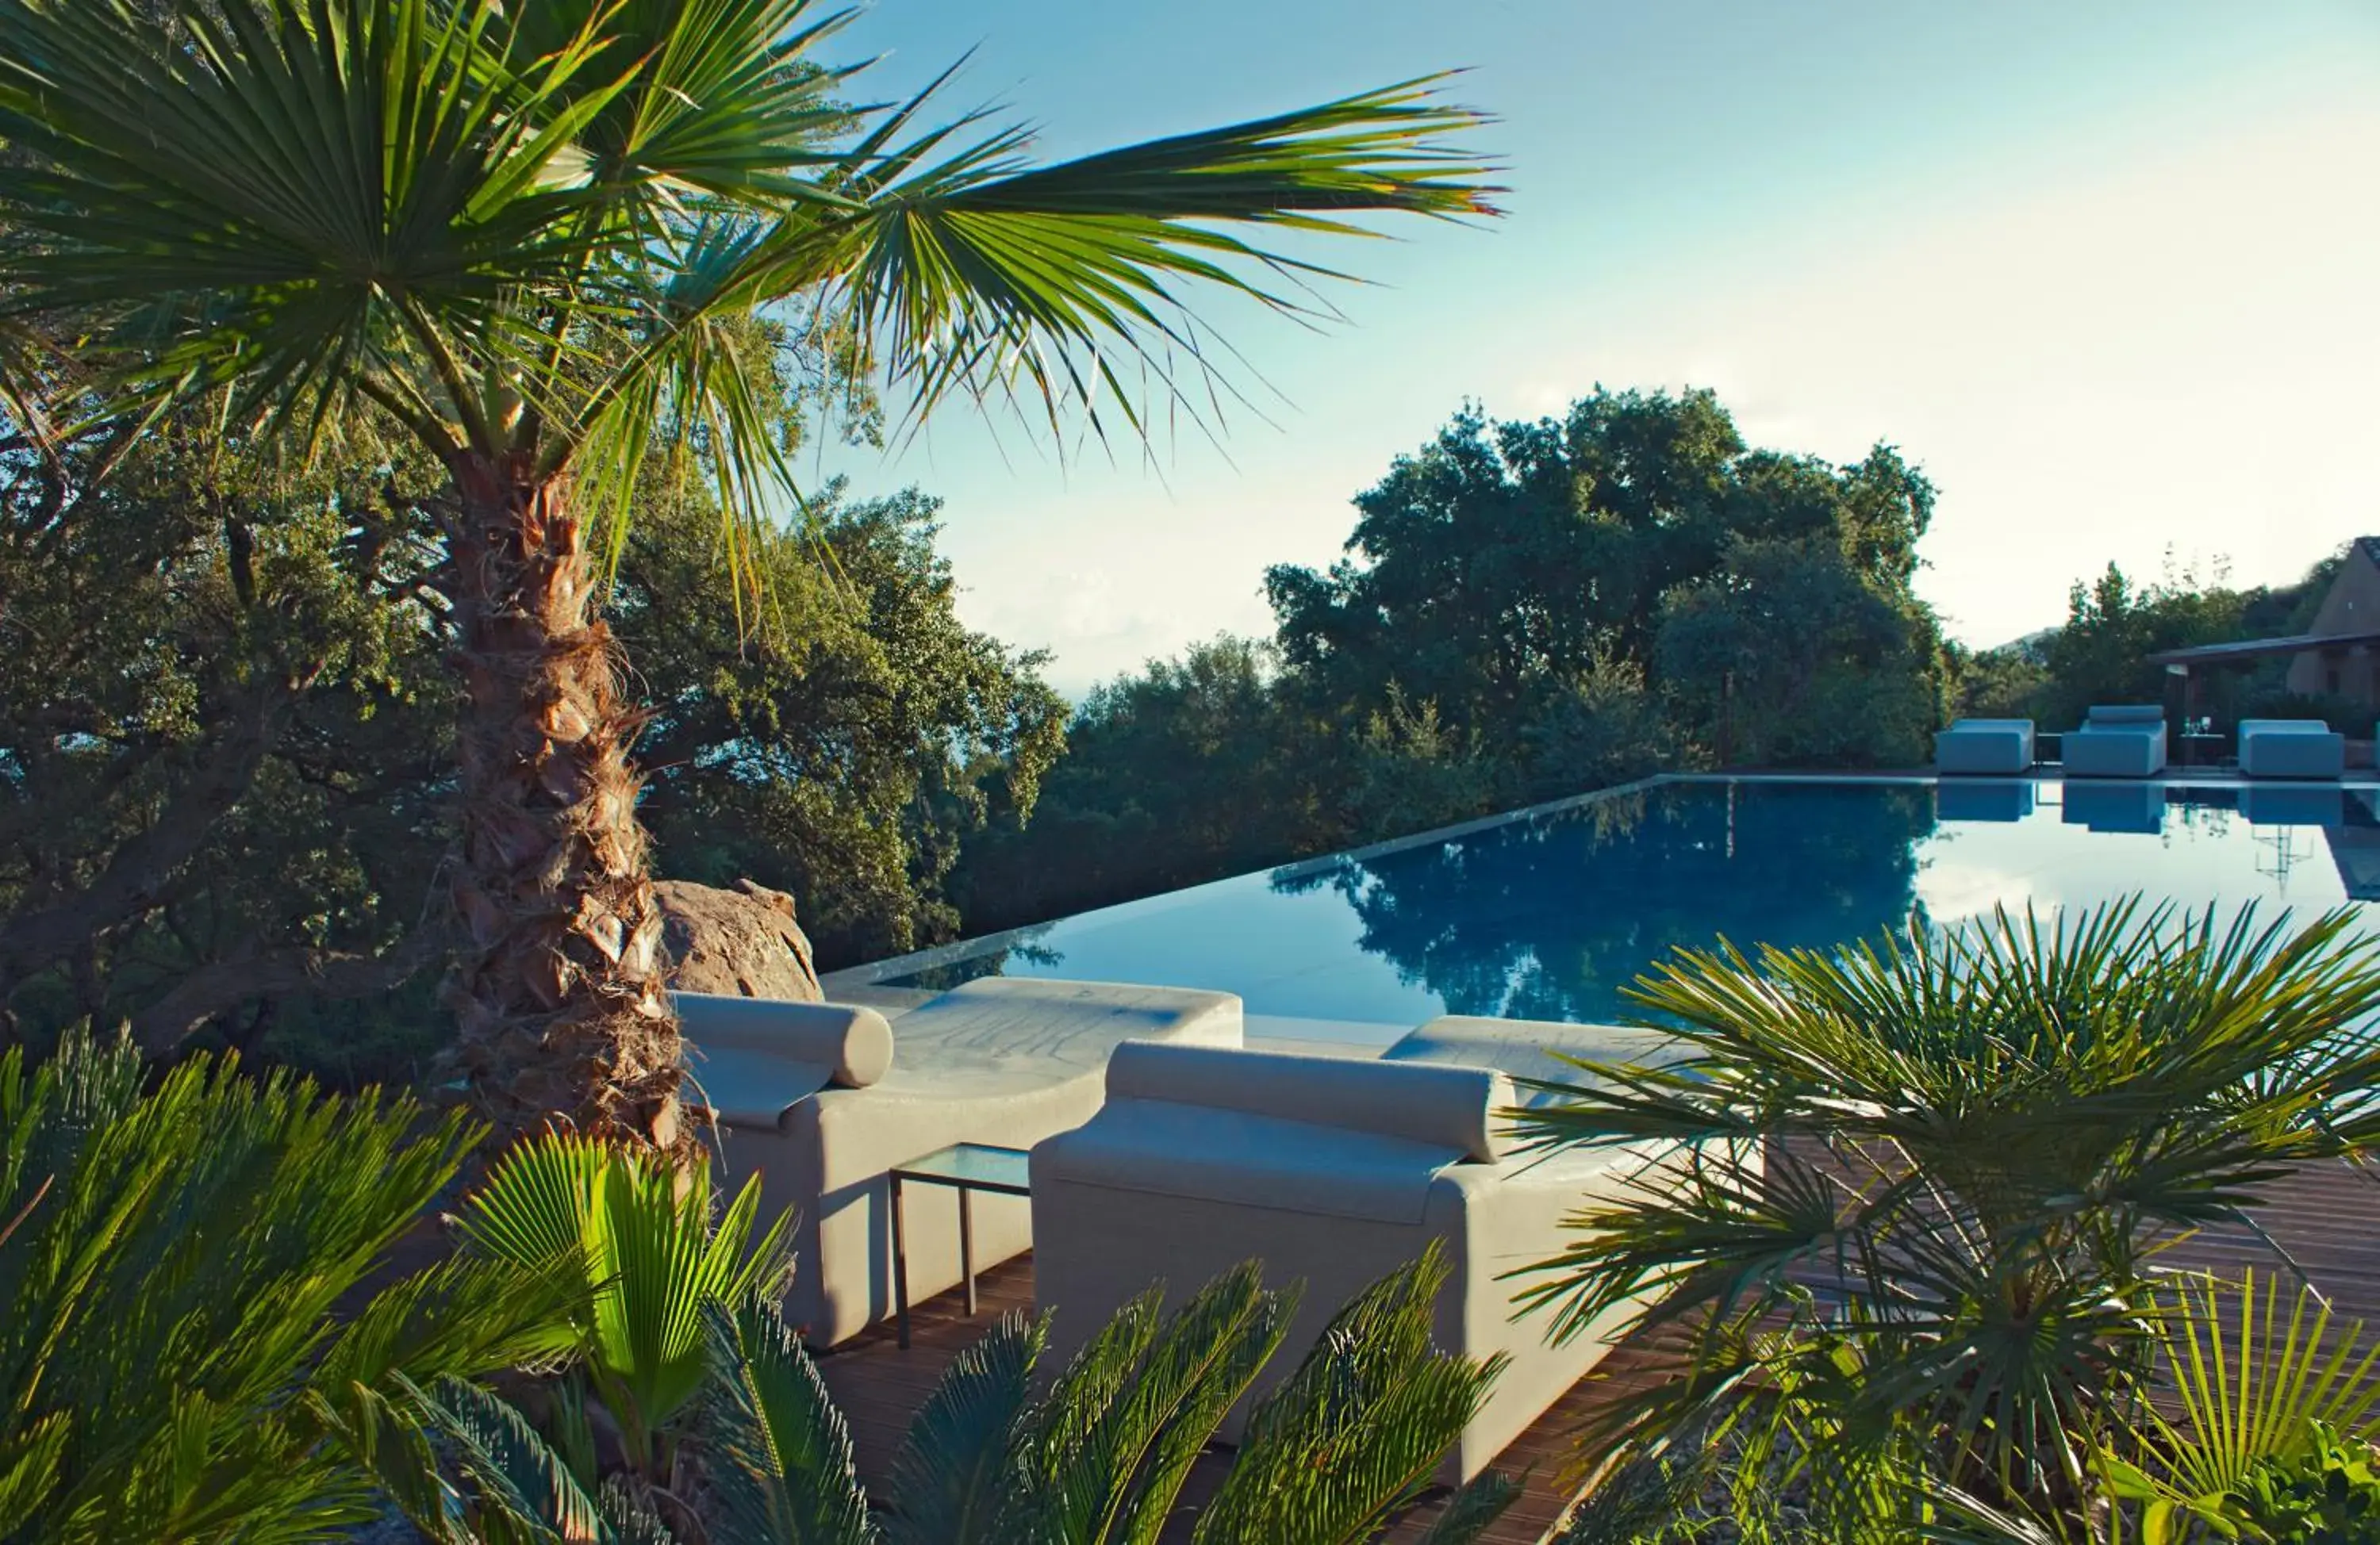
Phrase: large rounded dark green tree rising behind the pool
[{"left": 1266, "top": 390, "right": 1935, "bottom": 766}]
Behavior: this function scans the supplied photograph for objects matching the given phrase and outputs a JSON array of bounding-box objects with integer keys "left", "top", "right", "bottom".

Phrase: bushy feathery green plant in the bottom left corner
[{"left": 0, "top": 1043, "right": 583, "bottom": 1545}]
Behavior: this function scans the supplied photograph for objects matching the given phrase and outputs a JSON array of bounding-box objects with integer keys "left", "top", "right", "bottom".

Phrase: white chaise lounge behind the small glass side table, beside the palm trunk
[{"left": 676, "top": 976, "right": 1240, "bottom": 1348}]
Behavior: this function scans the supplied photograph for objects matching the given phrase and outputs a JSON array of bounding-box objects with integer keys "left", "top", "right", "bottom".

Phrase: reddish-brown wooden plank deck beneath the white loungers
[{"left": 819, "top": 1164, "right": 2380, "bottom": 1545}]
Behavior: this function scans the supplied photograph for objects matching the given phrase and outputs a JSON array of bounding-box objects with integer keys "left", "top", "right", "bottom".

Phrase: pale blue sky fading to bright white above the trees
[{"left": 807, "top": 0, "right": 2380, "bottom": 692}]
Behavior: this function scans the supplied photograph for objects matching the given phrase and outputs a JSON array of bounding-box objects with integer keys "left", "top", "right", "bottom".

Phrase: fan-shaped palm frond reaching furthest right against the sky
[{"left": 809, "top": 79, "right": 1495, "bottom": 450}]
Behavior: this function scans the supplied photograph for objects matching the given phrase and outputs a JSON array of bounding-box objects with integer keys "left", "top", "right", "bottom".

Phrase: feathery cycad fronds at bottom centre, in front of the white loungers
[{"left": 712, "top": 1252, "right": 1514, "bottom": 1545}]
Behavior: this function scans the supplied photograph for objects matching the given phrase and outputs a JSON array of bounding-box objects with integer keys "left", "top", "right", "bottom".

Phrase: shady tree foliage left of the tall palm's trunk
[{"left": 0, "top": 421, "right": 447, "bottom": 1067}]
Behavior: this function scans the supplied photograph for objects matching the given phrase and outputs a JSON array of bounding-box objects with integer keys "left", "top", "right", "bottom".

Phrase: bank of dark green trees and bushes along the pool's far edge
[{"left": 962, "top": 390, "right": 1944, "bottom": 931}]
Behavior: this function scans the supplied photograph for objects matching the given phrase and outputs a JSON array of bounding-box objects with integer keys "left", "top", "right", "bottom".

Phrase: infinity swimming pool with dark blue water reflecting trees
[{"left": 828, "top": 776, "right": 2380, "bottom": 1043}]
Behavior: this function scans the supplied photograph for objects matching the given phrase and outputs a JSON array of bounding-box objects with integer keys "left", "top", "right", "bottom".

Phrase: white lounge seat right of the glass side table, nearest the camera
[{"left": 1033, "top": 1019, "right": 1664, "bottom": 1483}]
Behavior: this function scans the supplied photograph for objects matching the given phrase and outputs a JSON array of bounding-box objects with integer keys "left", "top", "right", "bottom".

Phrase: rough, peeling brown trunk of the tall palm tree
[{"left": 447, "top": 454, "right": 700, "bottom": 1157}]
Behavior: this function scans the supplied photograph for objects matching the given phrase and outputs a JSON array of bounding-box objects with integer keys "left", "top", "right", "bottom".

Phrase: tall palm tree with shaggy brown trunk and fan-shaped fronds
[{"left": 0, "top": 0, "right": 1492, "bottom": 1150}]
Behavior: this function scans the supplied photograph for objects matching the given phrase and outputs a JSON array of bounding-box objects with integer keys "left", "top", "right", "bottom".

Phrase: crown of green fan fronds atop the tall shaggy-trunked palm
[{"left": 0, "top": 0, "right": 1490, "bottom": 507}]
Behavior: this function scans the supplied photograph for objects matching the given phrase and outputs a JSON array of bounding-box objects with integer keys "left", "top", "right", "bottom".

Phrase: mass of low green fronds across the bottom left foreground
[{"left": 0, "top": 1038, "right": 1514, "bottom": 1545}]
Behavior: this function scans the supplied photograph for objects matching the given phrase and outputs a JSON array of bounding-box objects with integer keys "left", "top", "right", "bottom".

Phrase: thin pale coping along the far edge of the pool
[{"left": 819, "top": 766, "right": 2380, "bottom": 993}]
